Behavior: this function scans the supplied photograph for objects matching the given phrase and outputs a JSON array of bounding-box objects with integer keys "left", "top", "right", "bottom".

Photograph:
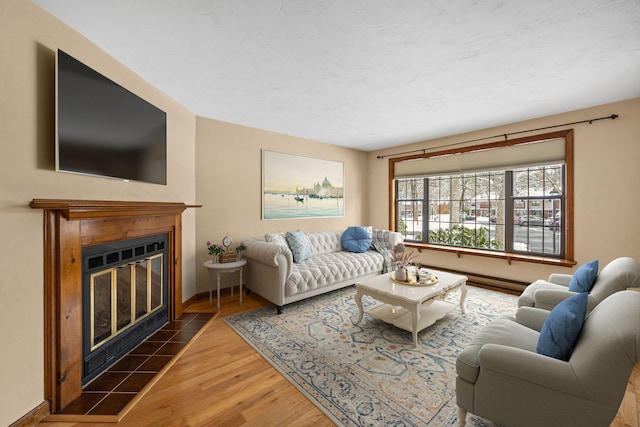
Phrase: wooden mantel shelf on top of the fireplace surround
[{"left": 29, "top": 199, "right": 202, "bottom": 220}]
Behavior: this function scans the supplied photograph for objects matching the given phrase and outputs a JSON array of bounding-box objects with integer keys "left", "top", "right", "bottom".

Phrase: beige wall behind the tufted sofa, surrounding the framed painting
[{"left": 196, "top": 117, "right": 368, "bottom": 292}]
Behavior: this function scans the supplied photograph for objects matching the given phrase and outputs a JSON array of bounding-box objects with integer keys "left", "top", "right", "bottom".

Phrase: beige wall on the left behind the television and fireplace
[{"left": 0, "top": 0, "right": 196, "bottom": 425}]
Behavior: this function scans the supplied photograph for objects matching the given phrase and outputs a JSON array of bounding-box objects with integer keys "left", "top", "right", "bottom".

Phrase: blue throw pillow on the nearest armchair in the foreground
[{"left": 536, "top": 293, "right": 589, "bottom": 361}]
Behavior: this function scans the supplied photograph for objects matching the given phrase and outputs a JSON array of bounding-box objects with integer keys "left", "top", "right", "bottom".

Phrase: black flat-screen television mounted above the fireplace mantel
[{"left": 56, "top": 50, "right": 167, "bottom": 185}]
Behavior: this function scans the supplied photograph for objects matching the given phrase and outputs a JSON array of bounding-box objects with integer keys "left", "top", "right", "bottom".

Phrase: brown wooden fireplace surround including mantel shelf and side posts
[{"left": 30, "top": 199, "right": 199, "bottom": 413}]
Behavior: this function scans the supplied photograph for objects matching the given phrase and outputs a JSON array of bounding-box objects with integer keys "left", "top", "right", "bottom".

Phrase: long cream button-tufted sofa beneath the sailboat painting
[{"left": 245, "top": 230, "right": 403, "bottom": 313}]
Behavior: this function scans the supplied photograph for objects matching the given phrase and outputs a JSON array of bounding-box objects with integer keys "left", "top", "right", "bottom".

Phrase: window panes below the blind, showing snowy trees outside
[{"left": 396, "top": 164, "right": 564, "bottom": 257}]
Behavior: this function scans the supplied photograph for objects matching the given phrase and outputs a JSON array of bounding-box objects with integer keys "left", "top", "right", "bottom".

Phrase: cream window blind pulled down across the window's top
[{"left": 394, "top": 138, "right": 565, "bottom": 178}]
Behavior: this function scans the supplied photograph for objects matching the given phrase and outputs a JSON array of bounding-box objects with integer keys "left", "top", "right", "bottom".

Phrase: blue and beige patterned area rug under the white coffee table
[{"left": 225, "top": 286, "right": 517, "bottom": 426}]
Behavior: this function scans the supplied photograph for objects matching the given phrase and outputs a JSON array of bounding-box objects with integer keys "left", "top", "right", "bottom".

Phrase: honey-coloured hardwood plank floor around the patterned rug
[{"left": 39, "top": 293, "right": 640, "bottom": 427}]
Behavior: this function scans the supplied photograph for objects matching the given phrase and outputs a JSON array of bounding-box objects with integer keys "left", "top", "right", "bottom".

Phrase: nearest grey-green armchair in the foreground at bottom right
[{"left": 456, "top": 291, "right": 640, "bottom": 427}]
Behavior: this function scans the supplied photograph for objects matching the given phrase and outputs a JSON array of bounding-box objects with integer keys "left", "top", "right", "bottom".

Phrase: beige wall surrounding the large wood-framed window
[{"left": 369, "top": 98, "right": 640, "bottom": 282}]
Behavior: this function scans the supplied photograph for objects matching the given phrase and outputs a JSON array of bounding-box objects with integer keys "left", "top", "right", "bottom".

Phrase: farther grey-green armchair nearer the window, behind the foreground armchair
[{"left": 518, "top": 257, "right": 640, "bottom": 311}]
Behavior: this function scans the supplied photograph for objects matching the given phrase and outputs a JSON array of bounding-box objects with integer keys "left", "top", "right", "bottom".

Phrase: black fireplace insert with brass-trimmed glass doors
[{"left": 82, "top": 235, "right": 168, "bottom": 384}]
